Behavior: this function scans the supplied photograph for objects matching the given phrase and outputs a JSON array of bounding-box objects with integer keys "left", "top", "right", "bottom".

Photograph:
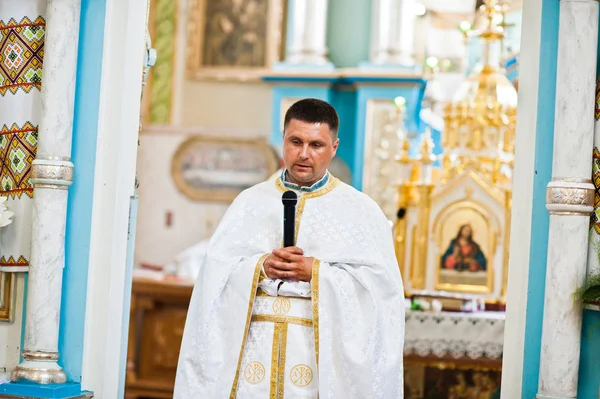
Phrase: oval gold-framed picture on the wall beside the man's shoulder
[{"left": 171, "top": 136, "right": 279, "bottom": 202}]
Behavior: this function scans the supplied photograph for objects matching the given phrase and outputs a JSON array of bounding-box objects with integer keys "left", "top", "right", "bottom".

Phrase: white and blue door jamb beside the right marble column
[{"left": 502, "top": 0, "right": 559, "bottom": 399}]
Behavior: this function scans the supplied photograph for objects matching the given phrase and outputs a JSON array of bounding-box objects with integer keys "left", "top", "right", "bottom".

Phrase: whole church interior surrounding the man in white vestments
[{"left": 0, "top": 0, "right": 600, "bottom": 399}]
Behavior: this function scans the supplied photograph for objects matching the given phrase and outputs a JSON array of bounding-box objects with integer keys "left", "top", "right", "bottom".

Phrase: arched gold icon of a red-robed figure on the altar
[{"left": 433, "top": 201, "right": 497, "bottom": 294}]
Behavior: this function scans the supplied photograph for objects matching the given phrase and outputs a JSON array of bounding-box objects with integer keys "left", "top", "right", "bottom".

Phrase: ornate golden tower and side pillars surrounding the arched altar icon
[{"left": 394, "top": 0, "right": 517, "bottom": 293}]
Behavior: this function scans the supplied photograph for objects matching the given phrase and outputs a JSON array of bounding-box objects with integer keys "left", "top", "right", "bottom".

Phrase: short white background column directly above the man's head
[{"left": 285, "top": 0, "right": 330, "bottom": 66}]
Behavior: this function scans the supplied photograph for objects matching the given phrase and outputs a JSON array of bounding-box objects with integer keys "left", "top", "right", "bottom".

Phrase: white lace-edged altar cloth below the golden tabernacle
[{"left": 404, "top": 311, "right": 505, "bottom": 359}]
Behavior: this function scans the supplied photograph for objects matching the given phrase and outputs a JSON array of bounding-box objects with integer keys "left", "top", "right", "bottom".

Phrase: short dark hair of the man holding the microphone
[{"left": 283, "top": 98, "right": 340, "bottom": 138}]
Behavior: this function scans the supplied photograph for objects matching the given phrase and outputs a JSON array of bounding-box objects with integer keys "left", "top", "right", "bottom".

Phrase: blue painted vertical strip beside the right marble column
[{"left": 522, "top": 0, "right": 559, "bottom": 399}]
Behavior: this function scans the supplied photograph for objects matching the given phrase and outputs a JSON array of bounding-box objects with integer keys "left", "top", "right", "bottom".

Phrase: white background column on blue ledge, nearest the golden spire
[{"left": 370, "top": 0, "right": 415, "bottom": 67}]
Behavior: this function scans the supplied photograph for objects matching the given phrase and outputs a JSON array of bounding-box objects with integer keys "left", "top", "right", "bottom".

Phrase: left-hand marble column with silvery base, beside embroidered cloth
[{"left": 12, "top": 0, "right": 80, "bottom": 384}]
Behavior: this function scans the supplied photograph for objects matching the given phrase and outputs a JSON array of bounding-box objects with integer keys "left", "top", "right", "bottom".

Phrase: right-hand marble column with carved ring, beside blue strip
[{"left": 537, "top": 0, "right": 598, "bottom": 399}]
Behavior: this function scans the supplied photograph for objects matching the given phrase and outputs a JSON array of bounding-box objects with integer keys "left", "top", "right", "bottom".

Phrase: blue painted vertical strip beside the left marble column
[{"left": 58, "top": 0, "right": 106, "bottom": 382}]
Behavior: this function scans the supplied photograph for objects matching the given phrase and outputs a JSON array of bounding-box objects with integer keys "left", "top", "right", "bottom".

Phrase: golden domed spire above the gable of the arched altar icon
[{"left": 441, "top": 0, "right": 517, "bottom": 186}]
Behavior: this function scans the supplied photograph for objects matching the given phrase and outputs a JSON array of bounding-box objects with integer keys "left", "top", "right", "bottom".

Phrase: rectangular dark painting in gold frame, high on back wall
[{"left": 187, "top": 0, "right": 286, "bottom": 81}]
